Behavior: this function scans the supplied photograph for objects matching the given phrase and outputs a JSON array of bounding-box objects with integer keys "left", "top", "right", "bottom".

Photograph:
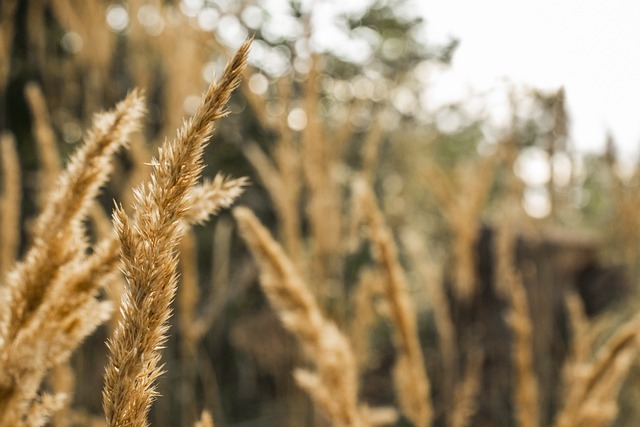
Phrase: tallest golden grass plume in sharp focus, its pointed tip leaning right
[{"left": 103, "top": 40, "right": 251, "bottom": 427}]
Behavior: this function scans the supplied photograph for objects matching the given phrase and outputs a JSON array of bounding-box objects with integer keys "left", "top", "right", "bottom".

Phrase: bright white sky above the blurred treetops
[{"left": 414, "top": 0, "right": 640, "bottom": 154}]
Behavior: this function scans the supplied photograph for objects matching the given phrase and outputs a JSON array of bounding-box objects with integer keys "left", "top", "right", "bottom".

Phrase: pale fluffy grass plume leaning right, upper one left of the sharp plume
[{"left": 0, "top": 88, "right": 143, "bottom": 342}]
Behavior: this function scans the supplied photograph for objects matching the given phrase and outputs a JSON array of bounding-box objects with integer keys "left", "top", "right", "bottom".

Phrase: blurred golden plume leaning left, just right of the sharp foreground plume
[{"left": 233, "top": 208, "right": 363, "bottom": 426}]
